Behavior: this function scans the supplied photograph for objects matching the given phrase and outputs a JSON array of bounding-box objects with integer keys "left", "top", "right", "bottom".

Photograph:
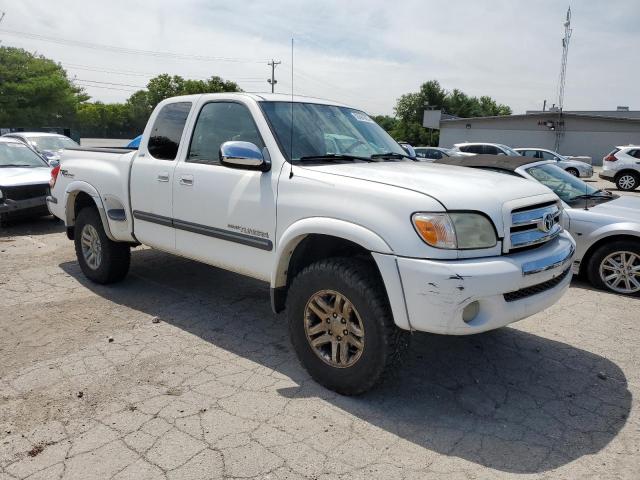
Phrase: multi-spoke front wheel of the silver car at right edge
[{"left": 587, "top": 240, "right": 640, "bottom": 295}]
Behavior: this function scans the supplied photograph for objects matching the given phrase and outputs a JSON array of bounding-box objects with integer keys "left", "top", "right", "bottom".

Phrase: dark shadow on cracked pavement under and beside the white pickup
[{"left": 60, "top": 249, "right": 631, "bottom": 473}]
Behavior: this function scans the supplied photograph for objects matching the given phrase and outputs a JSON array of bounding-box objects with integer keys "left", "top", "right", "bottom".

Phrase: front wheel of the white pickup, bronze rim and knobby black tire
[{"left": 286, "top": 258, "right": 409, "bottom": 395}]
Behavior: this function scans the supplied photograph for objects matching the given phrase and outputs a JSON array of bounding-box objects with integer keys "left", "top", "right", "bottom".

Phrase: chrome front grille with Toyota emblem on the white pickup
[{"left": 509, "top": 201, "right": 562, "bottom": 252}]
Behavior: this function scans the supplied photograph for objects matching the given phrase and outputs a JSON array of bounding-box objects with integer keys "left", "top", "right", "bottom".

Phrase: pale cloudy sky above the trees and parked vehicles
[{"left": 0, "top": 0, "right": 640, "bottom": 114}]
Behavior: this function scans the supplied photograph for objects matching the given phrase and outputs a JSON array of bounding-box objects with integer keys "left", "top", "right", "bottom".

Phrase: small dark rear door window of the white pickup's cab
[{"left": 147, "top": 102, "right": 191, "bottom": 160}]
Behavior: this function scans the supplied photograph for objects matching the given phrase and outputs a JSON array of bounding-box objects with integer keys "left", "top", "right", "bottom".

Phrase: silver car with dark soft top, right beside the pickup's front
[{"left": 438, "top": 156, "right": 640, "bottom": 295}]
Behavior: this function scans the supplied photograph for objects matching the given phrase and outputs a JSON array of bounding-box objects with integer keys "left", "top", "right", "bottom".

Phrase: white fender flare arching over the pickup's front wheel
[{"left": 271, "top": 217, "right": 393, "bottom": 288}]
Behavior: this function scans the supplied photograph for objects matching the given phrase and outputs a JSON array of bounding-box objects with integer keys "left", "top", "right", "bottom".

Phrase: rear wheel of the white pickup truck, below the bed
[{"left": 74, "top": 208, "right": 131, "bottom": 284}]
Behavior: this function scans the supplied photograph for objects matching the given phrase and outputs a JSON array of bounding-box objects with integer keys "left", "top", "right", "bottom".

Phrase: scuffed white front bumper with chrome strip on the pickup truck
[{"left": 397, "top": 233, "right": 575, "bottom": 335}]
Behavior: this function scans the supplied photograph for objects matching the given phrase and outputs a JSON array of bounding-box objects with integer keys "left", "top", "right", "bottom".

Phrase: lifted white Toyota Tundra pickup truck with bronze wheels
[{"left": 47, "top": 93, "right": 575, "bottom": 395}]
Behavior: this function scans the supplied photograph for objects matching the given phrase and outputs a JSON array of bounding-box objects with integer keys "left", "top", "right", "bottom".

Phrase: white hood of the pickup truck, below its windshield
[{"left": 304, "top": 162, "right": 551, "bottom": 213}]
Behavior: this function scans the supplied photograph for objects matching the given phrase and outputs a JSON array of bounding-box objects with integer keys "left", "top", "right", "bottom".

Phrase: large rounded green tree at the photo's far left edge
[{"left": 0, "top": 47, "right": 89, "bottom": 128}]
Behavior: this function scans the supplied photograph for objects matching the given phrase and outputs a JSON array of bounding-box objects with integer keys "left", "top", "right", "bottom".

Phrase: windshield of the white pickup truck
[{"left": 261, "top": 102, "right": 406, "bottom": 161}]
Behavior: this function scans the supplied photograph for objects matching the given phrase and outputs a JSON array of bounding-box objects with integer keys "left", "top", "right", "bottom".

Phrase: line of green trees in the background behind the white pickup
[{"left": 0, "top": 47, "right": 511, "bottom": 145}]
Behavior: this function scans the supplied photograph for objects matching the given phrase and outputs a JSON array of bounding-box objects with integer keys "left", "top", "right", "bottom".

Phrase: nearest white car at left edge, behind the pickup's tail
[{"left": 0, "top": 137, "right": 51, "bottom": 224}]
